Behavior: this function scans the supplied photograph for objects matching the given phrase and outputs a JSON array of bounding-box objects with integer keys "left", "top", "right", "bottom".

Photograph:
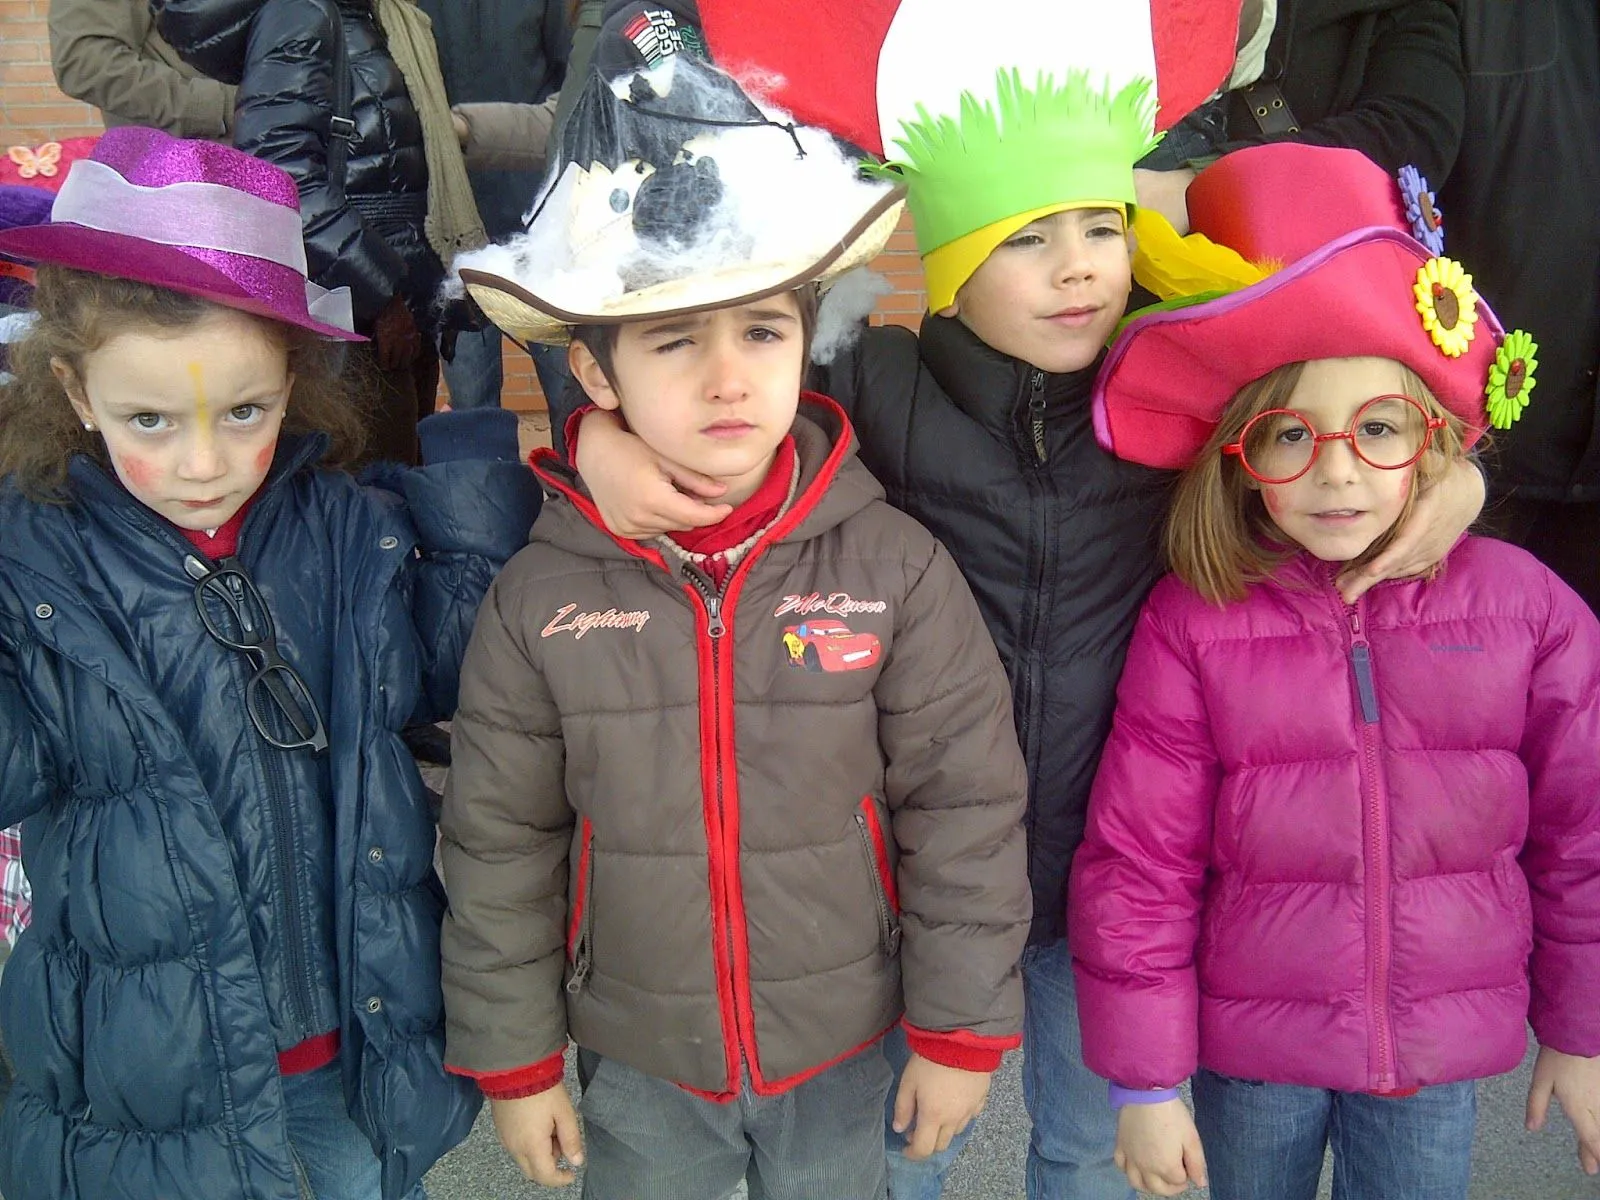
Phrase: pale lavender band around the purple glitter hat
[{"left": 50, "top": 158, "right": 355, "bottom": 331}]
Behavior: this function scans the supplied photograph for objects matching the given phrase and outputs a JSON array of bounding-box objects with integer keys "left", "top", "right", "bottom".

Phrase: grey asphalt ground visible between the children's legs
[{"left": 427, "top": 1053, "right": 1600, "bottom": 1200}]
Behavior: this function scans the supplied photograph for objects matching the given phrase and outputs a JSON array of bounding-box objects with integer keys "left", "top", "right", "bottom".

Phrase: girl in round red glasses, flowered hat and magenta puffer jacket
[{"left": 1069, "top": 144, "right": 1600, "bottom": 1200}]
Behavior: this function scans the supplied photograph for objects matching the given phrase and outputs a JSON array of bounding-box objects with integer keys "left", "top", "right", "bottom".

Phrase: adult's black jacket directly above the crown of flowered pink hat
[{"left": 1224, "top": 0, "right": 1465, "bottom": 184}]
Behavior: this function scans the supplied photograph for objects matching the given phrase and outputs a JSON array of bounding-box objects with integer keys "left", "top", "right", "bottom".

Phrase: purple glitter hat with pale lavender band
[{"left": 0, "top": 125, "right": 365, "bottom": 341}]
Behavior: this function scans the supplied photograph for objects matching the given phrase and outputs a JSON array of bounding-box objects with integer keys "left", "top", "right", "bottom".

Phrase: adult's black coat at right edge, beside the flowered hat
[{"left": 1440, "top": 0, "right": 1600, "bottom": 499}]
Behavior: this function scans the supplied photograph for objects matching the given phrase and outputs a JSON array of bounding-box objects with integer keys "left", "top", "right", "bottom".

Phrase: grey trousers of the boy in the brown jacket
[{"left": 578, "top": 1045, "right": 893, "bottom": 1200}]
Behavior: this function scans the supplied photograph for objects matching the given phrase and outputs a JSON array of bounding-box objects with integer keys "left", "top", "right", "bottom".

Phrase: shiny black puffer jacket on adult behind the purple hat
[{"left": 152, "top": 0, "right": 445, "bottom": 333}]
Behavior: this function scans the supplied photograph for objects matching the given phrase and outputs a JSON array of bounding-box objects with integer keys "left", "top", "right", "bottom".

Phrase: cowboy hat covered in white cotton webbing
[{"left": 456, "top": 54, "right": 901, "bottom": 342}]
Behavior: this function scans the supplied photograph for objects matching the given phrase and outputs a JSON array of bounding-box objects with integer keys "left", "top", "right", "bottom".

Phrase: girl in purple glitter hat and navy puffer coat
[{"left": 0, "top": 126, "right": 539, "bottom": 1200}]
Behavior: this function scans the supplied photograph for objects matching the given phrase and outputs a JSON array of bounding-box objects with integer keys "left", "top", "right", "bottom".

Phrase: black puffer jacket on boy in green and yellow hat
[{"left": 824, "top": 317, "right": 1171, "bottom": 942}]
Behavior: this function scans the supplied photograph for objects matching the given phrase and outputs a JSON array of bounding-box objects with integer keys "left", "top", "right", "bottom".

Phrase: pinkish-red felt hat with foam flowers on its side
[{"left": 1093, "top": 142, "right": 1536, "bottom": 467}]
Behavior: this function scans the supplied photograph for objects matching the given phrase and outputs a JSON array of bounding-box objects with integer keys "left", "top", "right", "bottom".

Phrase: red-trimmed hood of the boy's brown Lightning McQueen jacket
[{"left": 530, "top": 392, "right": 883, "bottom": 566}]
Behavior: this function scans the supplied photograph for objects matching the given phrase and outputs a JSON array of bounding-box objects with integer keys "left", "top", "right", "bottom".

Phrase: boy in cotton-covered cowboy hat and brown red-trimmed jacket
[{"left": 442, "top": 42, "right": 1029, "bottom": 1200}]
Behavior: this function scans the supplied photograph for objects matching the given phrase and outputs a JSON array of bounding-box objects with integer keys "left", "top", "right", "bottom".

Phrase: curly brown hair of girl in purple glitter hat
[{"left": 0, "top": 266, "right": 365, "bottom": 501}]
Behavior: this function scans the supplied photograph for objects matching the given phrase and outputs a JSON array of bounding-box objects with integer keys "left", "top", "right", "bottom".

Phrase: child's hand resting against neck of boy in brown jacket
[{"left": 578, "top": 411, "right": 733, "bottom": 541}]
